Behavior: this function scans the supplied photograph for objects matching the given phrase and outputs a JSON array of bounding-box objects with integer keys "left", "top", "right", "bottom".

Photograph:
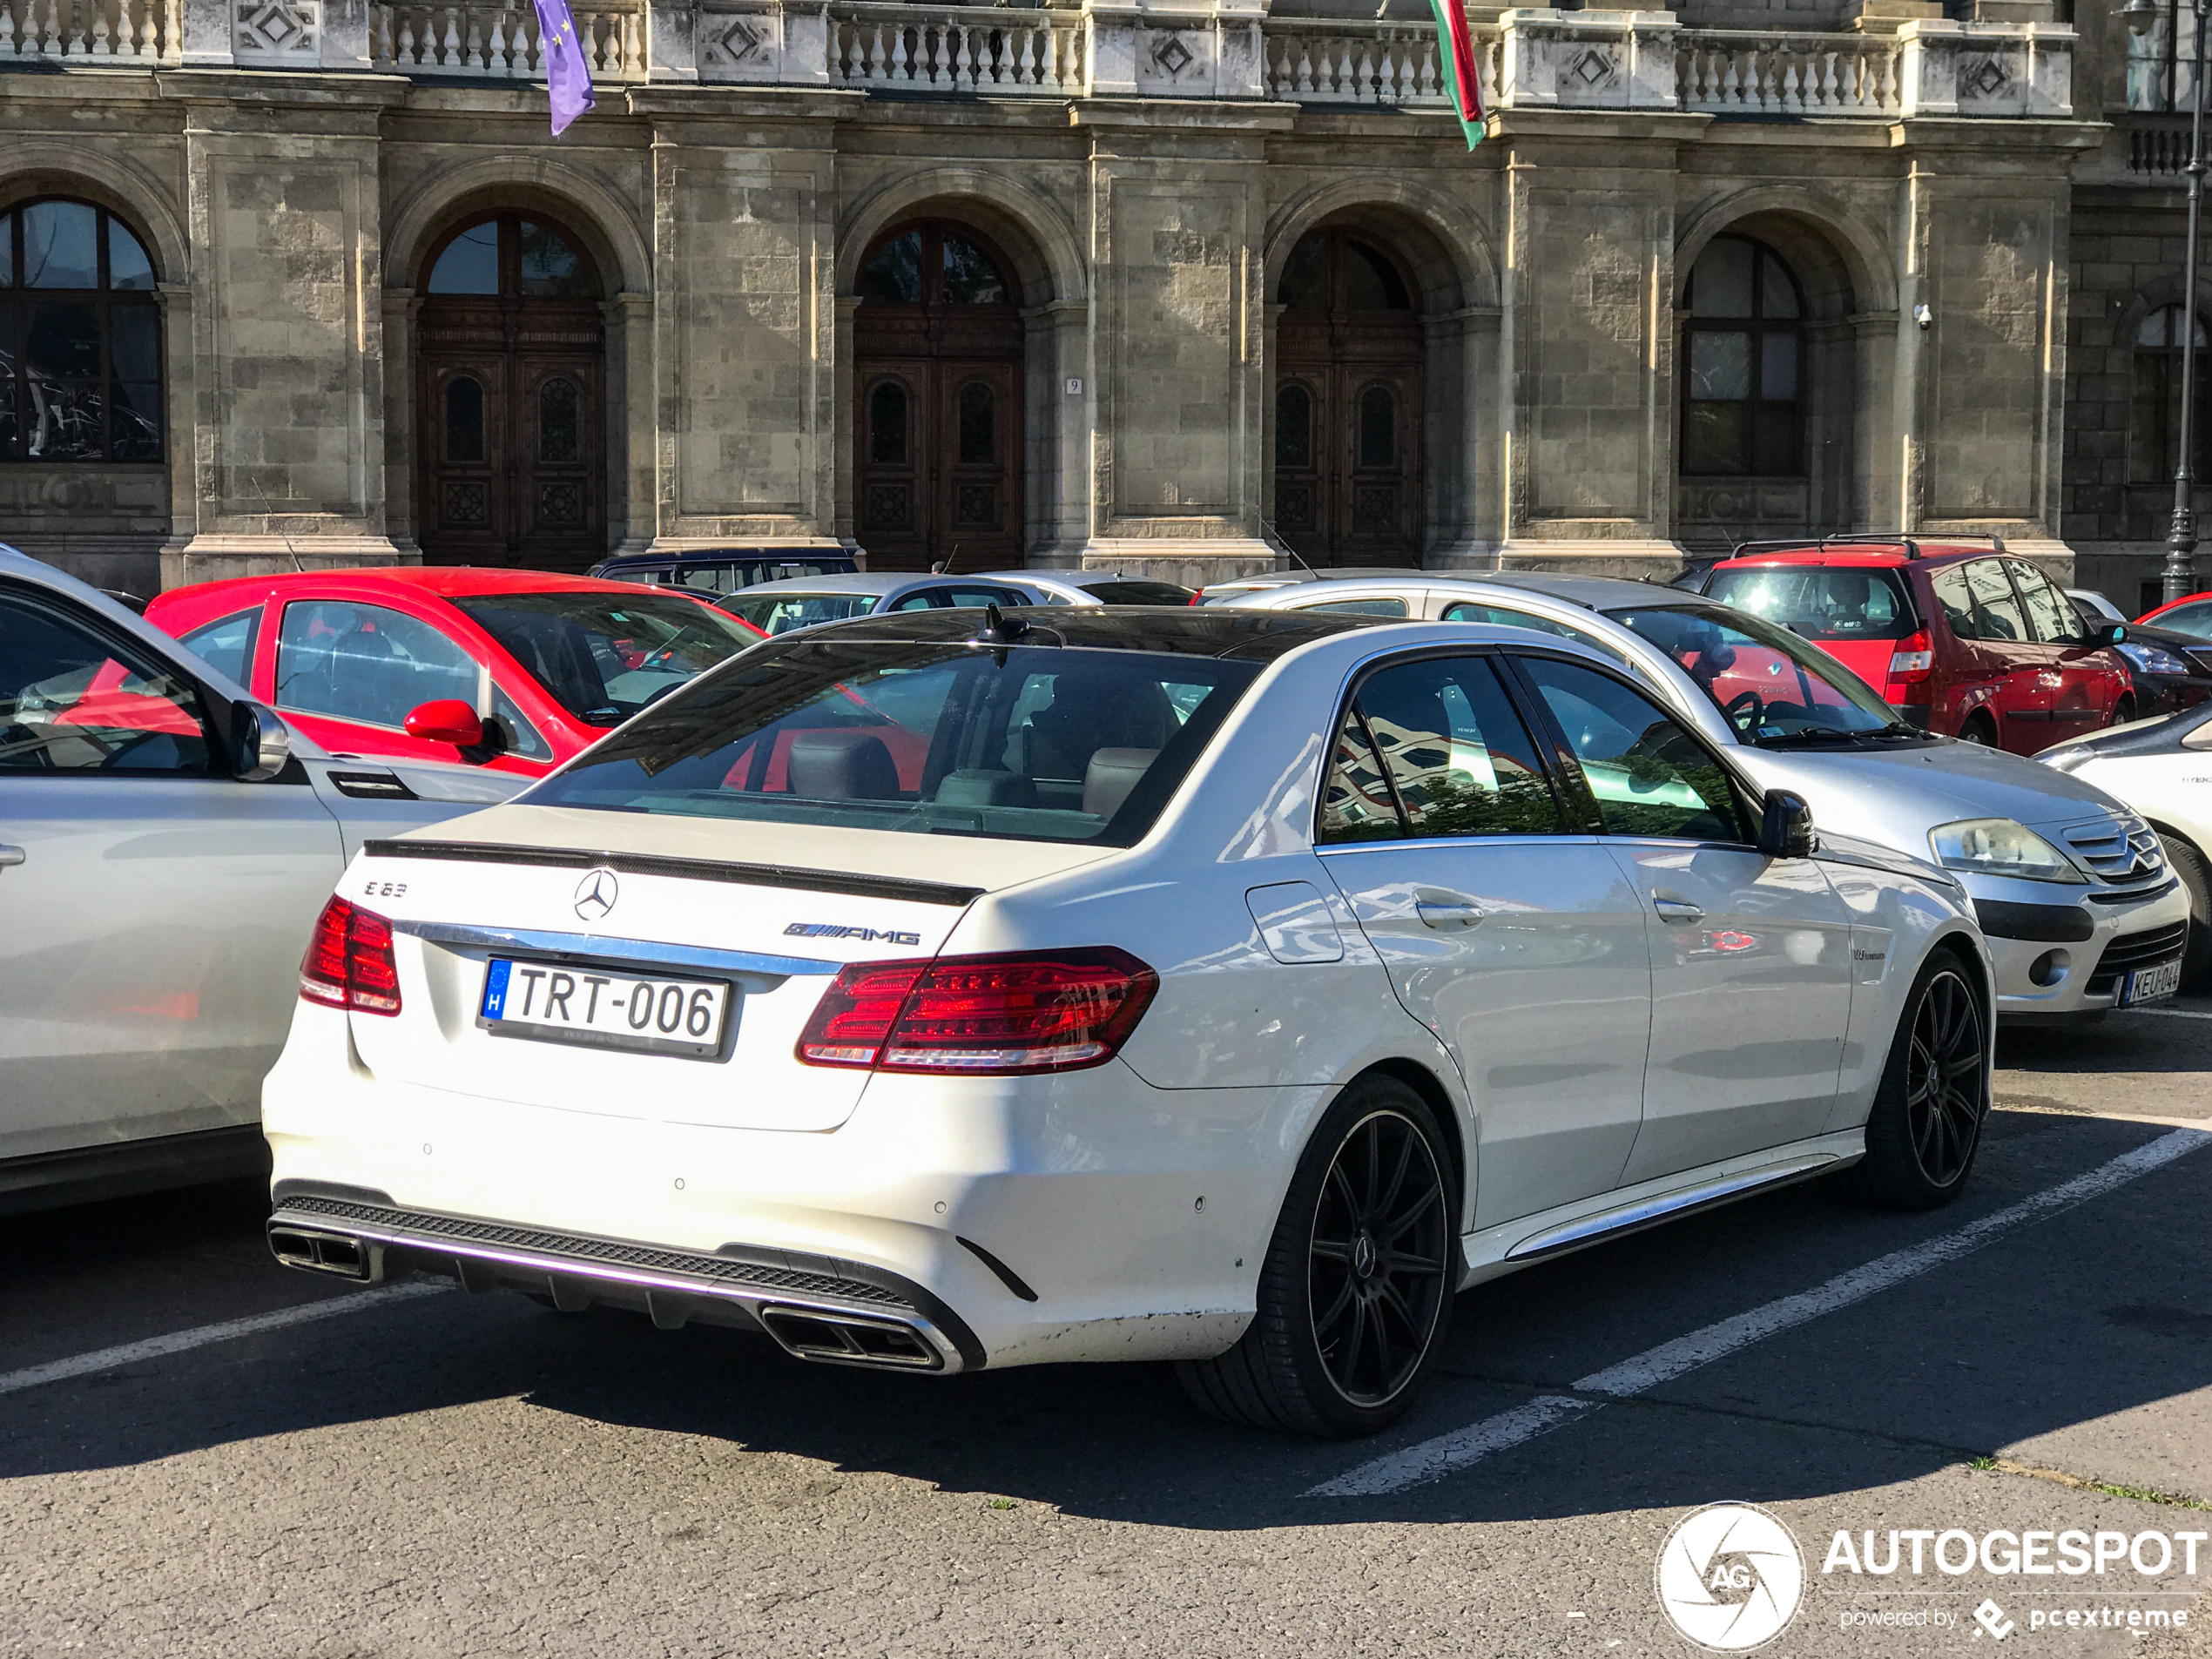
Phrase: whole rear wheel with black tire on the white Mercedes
[{"left": 1175, "top": 1075, "right": 1460, "bottom": 1440}]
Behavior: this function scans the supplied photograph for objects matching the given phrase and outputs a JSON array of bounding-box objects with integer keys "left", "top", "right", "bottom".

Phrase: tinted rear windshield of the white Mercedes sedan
[{"left": 524, "top": 637, "right": 1258, "bottom": 847}]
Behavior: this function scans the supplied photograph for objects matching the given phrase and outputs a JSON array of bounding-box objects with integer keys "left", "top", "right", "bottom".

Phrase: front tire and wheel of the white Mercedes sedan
[{"left": 1840, "top": 951, "right": 1988, "bottom": 1210}]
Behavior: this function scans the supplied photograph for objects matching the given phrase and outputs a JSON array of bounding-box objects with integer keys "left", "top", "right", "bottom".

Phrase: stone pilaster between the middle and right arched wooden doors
[{"left": 1075, "top": 99, "right": 1290, "bottom": 586}]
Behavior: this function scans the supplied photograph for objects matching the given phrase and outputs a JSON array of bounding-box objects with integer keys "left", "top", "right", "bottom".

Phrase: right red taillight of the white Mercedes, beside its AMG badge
[{"left": 799, "top": 945, "right": 1159, "bottom": 1075}]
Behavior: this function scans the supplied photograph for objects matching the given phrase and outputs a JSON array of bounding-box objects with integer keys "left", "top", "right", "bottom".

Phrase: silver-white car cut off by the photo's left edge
[{"left": 0, "top": 546, "right": 529, "bottom": 1212}]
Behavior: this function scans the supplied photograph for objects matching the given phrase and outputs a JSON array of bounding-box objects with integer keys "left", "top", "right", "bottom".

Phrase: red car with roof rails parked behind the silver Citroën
[{"left": 1705, "top": 537, "right": 2134, "bottom": 754}]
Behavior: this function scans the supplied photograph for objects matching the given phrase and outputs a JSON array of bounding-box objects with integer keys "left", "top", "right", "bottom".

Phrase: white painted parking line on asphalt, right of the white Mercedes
[{"left": 1305, "top": 1128, "right": 2212, "bottom": 1498}]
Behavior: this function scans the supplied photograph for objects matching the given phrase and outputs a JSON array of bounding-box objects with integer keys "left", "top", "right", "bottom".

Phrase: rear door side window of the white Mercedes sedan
[{"left": 1320, "top": 657, "right": 1564, "bottom": 840}]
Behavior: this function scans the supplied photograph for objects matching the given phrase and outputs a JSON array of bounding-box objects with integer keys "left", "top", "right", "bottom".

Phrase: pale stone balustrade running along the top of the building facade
[{"left": 0, "top": 0, "right": 2061, "bottom": 119}]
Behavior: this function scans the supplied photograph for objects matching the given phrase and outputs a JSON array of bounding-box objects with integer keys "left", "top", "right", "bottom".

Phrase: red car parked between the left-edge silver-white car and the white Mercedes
[{"left": 146, "top": 564, "right": 763, "bottom": 777}]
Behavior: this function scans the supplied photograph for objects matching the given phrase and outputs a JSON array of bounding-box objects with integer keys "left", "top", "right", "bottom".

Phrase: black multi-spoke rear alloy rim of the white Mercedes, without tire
[{"left": 1307, "top": 1110, "right": 1451, "bottom": 1406}]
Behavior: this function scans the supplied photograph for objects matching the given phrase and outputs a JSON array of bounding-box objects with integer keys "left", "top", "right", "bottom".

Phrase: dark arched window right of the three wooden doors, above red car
[{"left": 1681, "top": 237, "right": 1805, "bottom": 478}]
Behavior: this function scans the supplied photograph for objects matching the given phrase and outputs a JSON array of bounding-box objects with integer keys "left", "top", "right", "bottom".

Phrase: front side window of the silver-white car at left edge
[{"left": 0, "top": 593, "right": 210, "bottom": 777}]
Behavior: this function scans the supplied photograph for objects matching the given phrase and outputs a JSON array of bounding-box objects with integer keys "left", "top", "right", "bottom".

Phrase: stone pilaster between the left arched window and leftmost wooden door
[{"left": 166, "top": 86, "right": 405, "bottom": 582}]
